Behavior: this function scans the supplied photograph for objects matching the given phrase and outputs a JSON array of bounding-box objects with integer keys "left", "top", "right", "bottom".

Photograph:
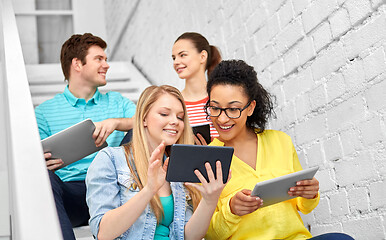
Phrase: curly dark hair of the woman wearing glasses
[{"left": 206, "top": 60, "right": 275, "bottom": 133}]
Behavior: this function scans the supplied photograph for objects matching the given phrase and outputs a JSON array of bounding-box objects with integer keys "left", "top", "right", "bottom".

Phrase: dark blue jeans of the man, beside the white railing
[{"left": 48, "top": 171, "right": 90, "bottom": 240}]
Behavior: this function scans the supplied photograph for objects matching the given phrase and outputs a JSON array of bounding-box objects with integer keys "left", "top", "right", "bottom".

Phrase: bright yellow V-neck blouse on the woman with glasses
[{"left": 206, "top": 130, "right": 320, "bottom": 240}]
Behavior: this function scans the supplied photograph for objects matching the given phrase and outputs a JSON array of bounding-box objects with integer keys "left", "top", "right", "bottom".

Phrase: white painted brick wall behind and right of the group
[{"left": 106, "top": 0, "right": 386, "bottom": 239}]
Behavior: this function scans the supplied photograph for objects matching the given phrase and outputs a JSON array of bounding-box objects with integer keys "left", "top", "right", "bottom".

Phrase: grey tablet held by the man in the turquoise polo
[{"left": 41, "top": 119, "right": 107, "bottom": 168}]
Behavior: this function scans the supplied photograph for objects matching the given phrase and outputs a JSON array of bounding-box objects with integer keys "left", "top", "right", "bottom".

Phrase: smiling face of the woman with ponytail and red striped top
[{"left": 172, "top": 39, "right": 208, "bottom": 79}]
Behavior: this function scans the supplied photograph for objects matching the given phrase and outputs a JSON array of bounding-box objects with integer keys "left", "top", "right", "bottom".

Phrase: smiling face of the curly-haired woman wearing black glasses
[{"left": 209, "top": 85, "right": 256, "bottom": 142}]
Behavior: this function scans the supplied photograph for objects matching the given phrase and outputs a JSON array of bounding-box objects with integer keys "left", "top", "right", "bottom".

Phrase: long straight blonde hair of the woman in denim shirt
[{"left": 124, "top": 85, "right": 201, "bottom": 222}]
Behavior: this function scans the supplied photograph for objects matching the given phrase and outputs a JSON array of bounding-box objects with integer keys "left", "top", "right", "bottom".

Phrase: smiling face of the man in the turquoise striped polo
[{"left": 77, "top": 45, "right": 110, "bottom": 88}]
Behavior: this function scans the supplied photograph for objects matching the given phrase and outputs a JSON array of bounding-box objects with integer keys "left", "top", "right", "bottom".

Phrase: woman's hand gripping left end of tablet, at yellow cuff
[{"left": 229, "top": 189, "right": 263, "bottom": 216}]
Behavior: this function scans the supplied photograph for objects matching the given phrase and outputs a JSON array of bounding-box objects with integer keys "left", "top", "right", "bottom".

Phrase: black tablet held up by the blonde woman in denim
[{"left": 166, "top": 144, "right": 233, "bottom": 183}]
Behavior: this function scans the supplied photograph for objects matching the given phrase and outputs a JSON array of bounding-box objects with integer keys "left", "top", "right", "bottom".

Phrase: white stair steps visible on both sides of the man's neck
[{"left": 26, "top": 62, "right": 151, "bottom": 107}]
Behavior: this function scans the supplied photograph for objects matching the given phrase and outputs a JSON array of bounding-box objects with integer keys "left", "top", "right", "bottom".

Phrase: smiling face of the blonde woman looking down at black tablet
[{"left": 143, "top": 93, "right": 184, "bottom": 149}]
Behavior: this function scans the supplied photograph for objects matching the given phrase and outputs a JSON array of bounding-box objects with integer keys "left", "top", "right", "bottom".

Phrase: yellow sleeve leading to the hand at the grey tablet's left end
[{"left": 205, "top": 197, "right": 241, "bottom": 240}]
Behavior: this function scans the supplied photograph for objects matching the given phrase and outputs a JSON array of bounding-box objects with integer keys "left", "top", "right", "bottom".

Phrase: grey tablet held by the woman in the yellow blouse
[{"left": 251, "top": 167, "right": 319, "bottom": 207}]
